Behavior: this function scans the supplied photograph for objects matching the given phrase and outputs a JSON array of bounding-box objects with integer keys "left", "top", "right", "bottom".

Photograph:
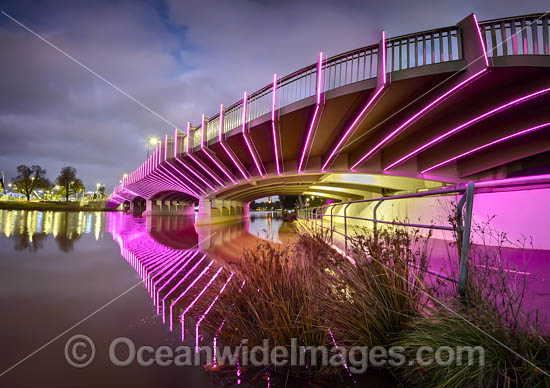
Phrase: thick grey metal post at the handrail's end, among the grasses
[{"left": 457, "top": 182, "right": 475, "bottom": 296}]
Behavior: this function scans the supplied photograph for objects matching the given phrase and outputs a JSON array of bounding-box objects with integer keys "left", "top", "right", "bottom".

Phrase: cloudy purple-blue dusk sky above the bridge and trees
[{"left": 0, "top": 0, "right": 550, "bottom": 192}]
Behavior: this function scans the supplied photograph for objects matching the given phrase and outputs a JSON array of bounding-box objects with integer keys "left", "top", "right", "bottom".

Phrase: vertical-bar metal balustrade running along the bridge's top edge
[{"left": 176, "top": 14, "right": 550, "bottom": 146}]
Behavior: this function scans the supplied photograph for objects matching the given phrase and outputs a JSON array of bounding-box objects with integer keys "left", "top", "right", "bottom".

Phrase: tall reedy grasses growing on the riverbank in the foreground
[{"left": 198, "top": 220, "right": 550, "bottom": 387}]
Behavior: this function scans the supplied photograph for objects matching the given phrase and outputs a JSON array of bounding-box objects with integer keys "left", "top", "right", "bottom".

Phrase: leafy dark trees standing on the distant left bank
[{"left": 1, "top": 165, "right": 105, "bottom": 201}]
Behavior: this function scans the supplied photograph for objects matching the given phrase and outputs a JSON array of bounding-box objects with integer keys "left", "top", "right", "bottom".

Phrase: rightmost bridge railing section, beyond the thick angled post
[{"left": 479, "top": 14, "right": 550, "bottom": 57}]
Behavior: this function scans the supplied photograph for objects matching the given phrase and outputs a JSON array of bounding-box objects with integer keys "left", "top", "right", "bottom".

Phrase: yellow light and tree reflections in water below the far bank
[{"left": 0, "top": 210, "right": 105, "bottom": 252}]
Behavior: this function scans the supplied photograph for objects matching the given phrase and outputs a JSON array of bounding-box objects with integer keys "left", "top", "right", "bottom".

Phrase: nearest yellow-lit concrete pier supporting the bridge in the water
[{"left": 195, "top": 199, "right": 248, "bottom": 225}]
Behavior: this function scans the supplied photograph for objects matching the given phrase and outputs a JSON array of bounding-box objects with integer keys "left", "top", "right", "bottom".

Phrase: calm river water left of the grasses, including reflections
[{"left": 0, "top": 210, "right": 294, "bottom": 387}]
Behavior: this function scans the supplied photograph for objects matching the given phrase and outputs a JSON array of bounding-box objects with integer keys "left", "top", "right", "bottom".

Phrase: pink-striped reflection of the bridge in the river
[{"left": 107, "top": 212, "right": 292, "bottom": 346}]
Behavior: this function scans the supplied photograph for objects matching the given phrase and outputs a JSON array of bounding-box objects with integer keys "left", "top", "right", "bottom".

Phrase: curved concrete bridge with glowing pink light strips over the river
[{"left": 111, "top": 14, "right": 550, "bottom": 236}]
